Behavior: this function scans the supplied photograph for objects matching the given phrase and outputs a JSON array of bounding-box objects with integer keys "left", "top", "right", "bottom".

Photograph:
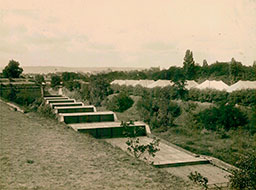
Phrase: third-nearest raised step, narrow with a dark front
[{"left": 54, "top": 106, "right": 96, "bottom": 114}]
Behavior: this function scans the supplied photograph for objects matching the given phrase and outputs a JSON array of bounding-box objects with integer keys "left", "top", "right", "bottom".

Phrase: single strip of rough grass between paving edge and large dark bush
[{"left": 153, "top": 127, "right": 256, "bottom": 165}]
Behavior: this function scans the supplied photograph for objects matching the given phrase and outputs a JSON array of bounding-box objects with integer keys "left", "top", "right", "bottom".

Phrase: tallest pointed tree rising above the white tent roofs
[{"left": 183, "top": 49, "right": 195, "bottom": 80}]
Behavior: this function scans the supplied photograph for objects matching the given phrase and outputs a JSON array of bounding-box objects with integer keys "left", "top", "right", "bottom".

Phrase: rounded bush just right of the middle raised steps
[{"left": 107, "top": 92, "right": 134, "bottom": 112}]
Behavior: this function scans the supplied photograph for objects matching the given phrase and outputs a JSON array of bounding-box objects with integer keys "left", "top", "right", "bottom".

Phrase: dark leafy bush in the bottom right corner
[{"left": 229, "top": 152, "right": 256, "bottom": 190}]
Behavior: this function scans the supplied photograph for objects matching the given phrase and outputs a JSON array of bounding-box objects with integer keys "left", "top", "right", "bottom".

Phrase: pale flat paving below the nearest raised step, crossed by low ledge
[{"left": 105, "top": 137, "right": 230, "bottom": 186}]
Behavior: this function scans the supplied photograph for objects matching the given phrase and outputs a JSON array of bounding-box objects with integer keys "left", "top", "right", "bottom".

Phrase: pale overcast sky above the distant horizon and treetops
[{"left": 0, "top": 0, "right": 256, "bottom": 68}]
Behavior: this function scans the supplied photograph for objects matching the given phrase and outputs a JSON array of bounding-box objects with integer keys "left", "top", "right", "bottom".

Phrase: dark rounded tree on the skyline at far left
[{"left": 3, "top": 60, "right": 23, "bottom": 78}]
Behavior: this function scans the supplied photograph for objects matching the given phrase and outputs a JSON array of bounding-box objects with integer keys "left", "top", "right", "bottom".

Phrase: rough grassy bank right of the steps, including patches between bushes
[{"left": 112, "top": 97, "right": 256, "bottom": 164}]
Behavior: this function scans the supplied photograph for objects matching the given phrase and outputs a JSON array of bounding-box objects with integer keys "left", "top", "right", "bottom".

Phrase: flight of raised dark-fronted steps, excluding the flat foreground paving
[{"left": 44, "top": 96, "right": 150, "bottom": 138}]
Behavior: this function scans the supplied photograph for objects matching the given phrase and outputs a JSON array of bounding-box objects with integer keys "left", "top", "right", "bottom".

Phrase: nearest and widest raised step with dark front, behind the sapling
[{"left": 69, "top": 121, "right": 149, "bottom": 138}]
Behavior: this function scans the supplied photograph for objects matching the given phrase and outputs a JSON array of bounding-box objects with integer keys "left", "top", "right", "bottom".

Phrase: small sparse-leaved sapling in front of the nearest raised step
[{"left": 121, "top": 121, "right": 160, "bottom": 164}]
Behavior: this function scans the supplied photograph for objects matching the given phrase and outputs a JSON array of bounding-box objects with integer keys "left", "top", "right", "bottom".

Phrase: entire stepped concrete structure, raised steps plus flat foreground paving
[{"left": 44, "top": 96, "right": 229, "bottom": 185}]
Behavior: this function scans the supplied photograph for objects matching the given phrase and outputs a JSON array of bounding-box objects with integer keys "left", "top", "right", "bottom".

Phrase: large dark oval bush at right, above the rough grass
[{"left": 195, "top": 105, "right": 248, "bottom": 131}]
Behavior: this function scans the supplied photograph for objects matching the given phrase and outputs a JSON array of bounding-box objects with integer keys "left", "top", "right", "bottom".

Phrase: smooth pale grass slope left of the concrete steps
[{"left": 0, "top": 102, "right": 194, "bottom": 190}]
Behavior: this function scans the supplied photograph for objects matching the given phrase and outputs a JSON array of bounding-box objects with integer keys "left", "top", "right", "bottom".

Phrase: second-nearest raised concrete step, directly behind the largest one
[{"left": 58, "top": 111, "right": 116, "bottom": 124}]
